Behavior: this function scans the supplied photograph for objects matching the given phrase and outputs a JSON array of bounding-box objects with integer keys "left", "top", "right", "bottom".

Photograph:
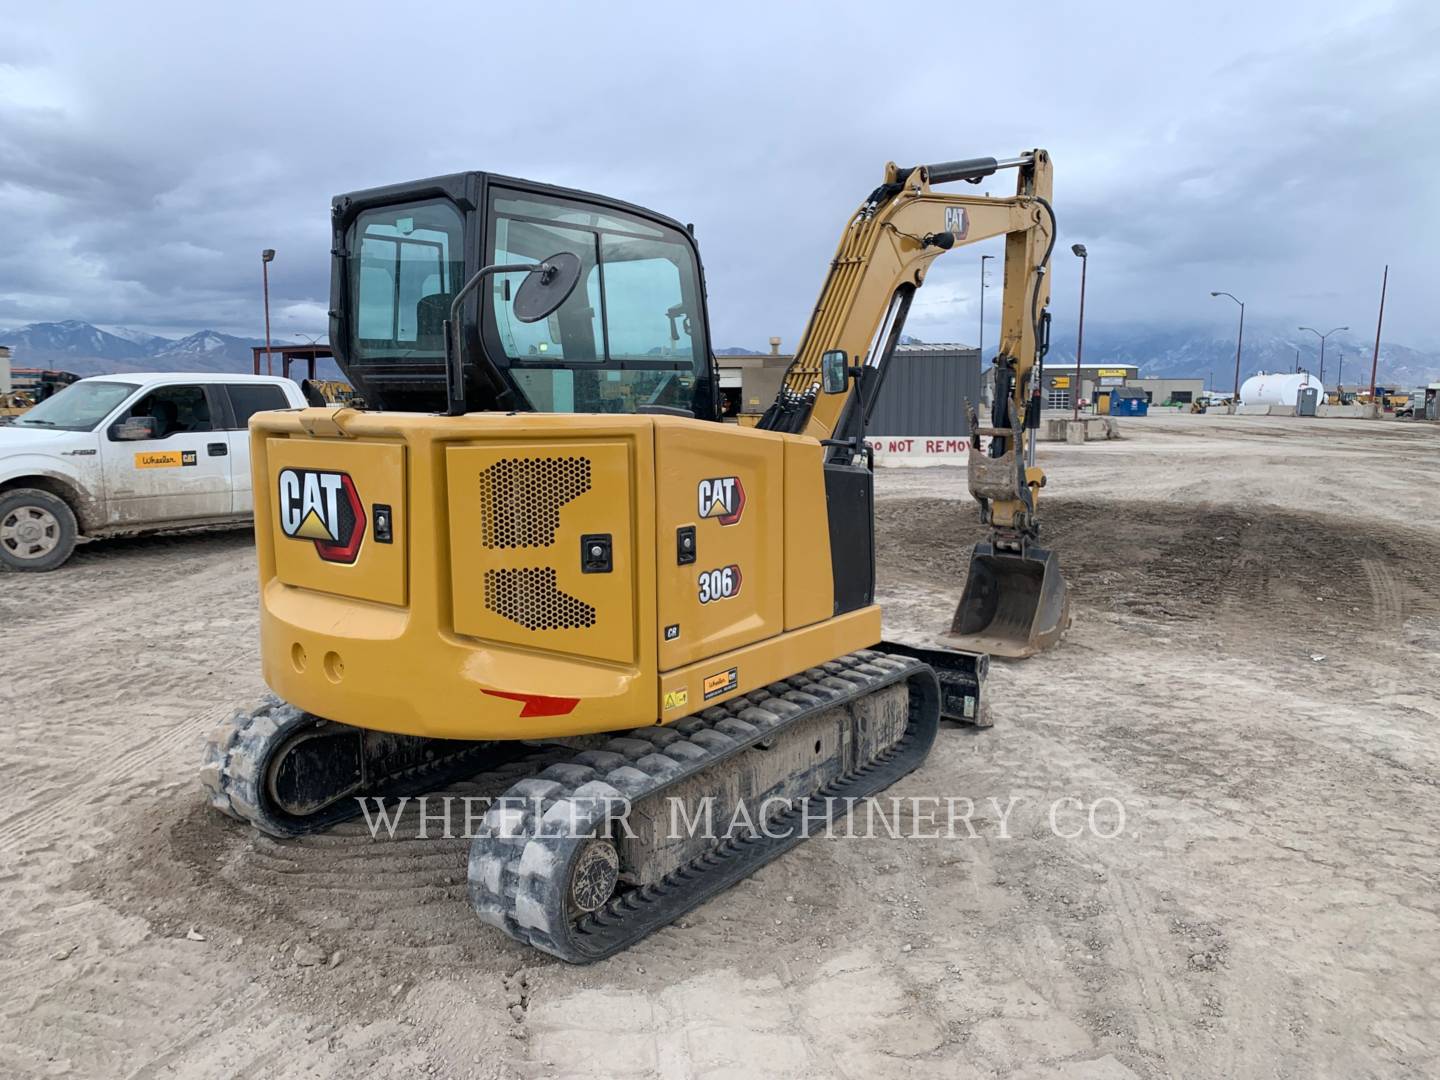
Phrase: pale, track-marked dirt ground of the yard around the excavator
[{"left": 8, "top": 416, "right": 1440, "bottom": 1080}]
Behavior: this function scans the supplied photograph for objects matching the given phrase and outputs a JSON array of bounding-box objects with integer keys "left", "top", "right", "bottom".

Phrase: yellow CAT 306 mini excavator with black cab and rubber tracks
[{"left": 202, "top": 150, "right": 1063, "bottom": 962}]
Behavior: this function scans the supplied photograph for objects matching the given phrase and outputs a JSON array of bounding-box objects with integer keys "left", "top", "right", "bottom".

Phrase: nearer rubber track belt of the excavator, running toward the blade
[{"left": 468, "top": 651, "right": 940, "bottom": 963}]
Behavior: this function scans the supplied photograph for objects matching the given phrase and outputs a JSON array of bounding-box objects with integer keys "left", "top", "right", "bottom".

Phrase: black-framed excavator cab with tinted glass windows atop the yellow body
[{"left": 330, "top": 171, "right": 719, "bottom": 420}]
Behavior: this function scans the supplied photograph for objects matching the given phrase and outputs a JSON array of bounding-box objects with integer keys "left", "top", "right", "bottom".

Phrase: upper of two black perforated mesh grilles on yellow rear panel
[{"left": 480, "top": 458, "right": 590, "bottom": 547}]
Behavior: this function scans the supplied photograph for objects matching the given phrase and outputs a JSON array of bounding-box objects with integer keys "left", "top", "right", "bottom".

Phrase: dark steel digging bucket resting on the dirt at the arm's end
[{"left": 945, "top": 543, "right": 1070, "bottom": 658}]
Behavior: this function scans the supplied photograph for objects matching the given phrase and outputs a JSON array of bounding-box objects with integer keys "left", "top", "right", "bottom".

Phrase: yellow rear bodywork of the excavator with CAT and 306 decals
[{"left": 251, "top": 409, "right": 880, "bottom": 739}]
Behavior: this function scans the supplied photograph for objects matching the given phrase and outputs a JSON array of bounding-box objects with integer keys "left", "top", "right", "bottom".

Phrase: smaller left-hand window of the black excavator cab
[{"left": 348, "top": 200, "right": 465, "bottom": 360}]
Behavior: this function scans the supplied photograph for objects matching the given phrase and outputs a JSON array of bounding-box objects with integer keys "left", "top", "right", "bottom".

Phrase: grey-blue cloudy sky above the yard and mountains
[{"left": 0, "top": 0, "right": 1440, "bottom": 347}]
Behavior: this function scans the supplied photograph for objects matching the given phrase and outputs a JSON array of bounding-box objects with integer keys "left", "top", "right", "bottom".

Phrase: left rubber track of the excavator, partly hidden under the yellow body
[{"left": 200, "top": 694, "right": 512, "bottom": 837}]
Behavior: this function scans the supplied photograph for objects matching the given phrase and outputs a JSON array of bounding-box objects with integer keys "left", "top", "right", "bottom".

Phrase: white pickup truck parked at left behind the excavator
[{"left": 0, "top": 373, "right": 305, "bottom": 570}]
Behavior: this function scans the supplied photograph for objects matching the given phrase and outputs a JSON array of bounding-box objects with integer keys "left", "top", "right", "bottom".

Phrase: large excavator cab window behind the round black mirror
[{"left": 488, "top": 190, "right": 708, "bottom": 413}]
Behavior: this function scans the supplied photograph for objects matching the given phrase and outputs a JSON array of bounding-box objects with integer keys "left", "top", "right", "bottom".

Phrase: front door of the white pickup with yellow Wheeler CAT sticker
[{"left": 101, "top": 383, "right": 232, "bottom": 524}]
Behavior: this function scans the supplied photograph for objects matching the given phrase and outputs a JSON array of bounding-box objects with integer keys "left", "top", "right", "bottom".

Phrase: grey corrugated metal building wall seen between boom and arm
[{"left": 867, "top": 346, "right": 981, "bottom": 435}]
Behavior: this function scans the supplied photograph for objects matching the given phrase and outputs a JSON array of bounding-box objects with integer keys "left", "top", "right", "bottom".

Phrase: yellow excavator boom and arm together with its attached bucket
[{"left": 760, "top": 150, "right": 1068, "bottom": 657}]
